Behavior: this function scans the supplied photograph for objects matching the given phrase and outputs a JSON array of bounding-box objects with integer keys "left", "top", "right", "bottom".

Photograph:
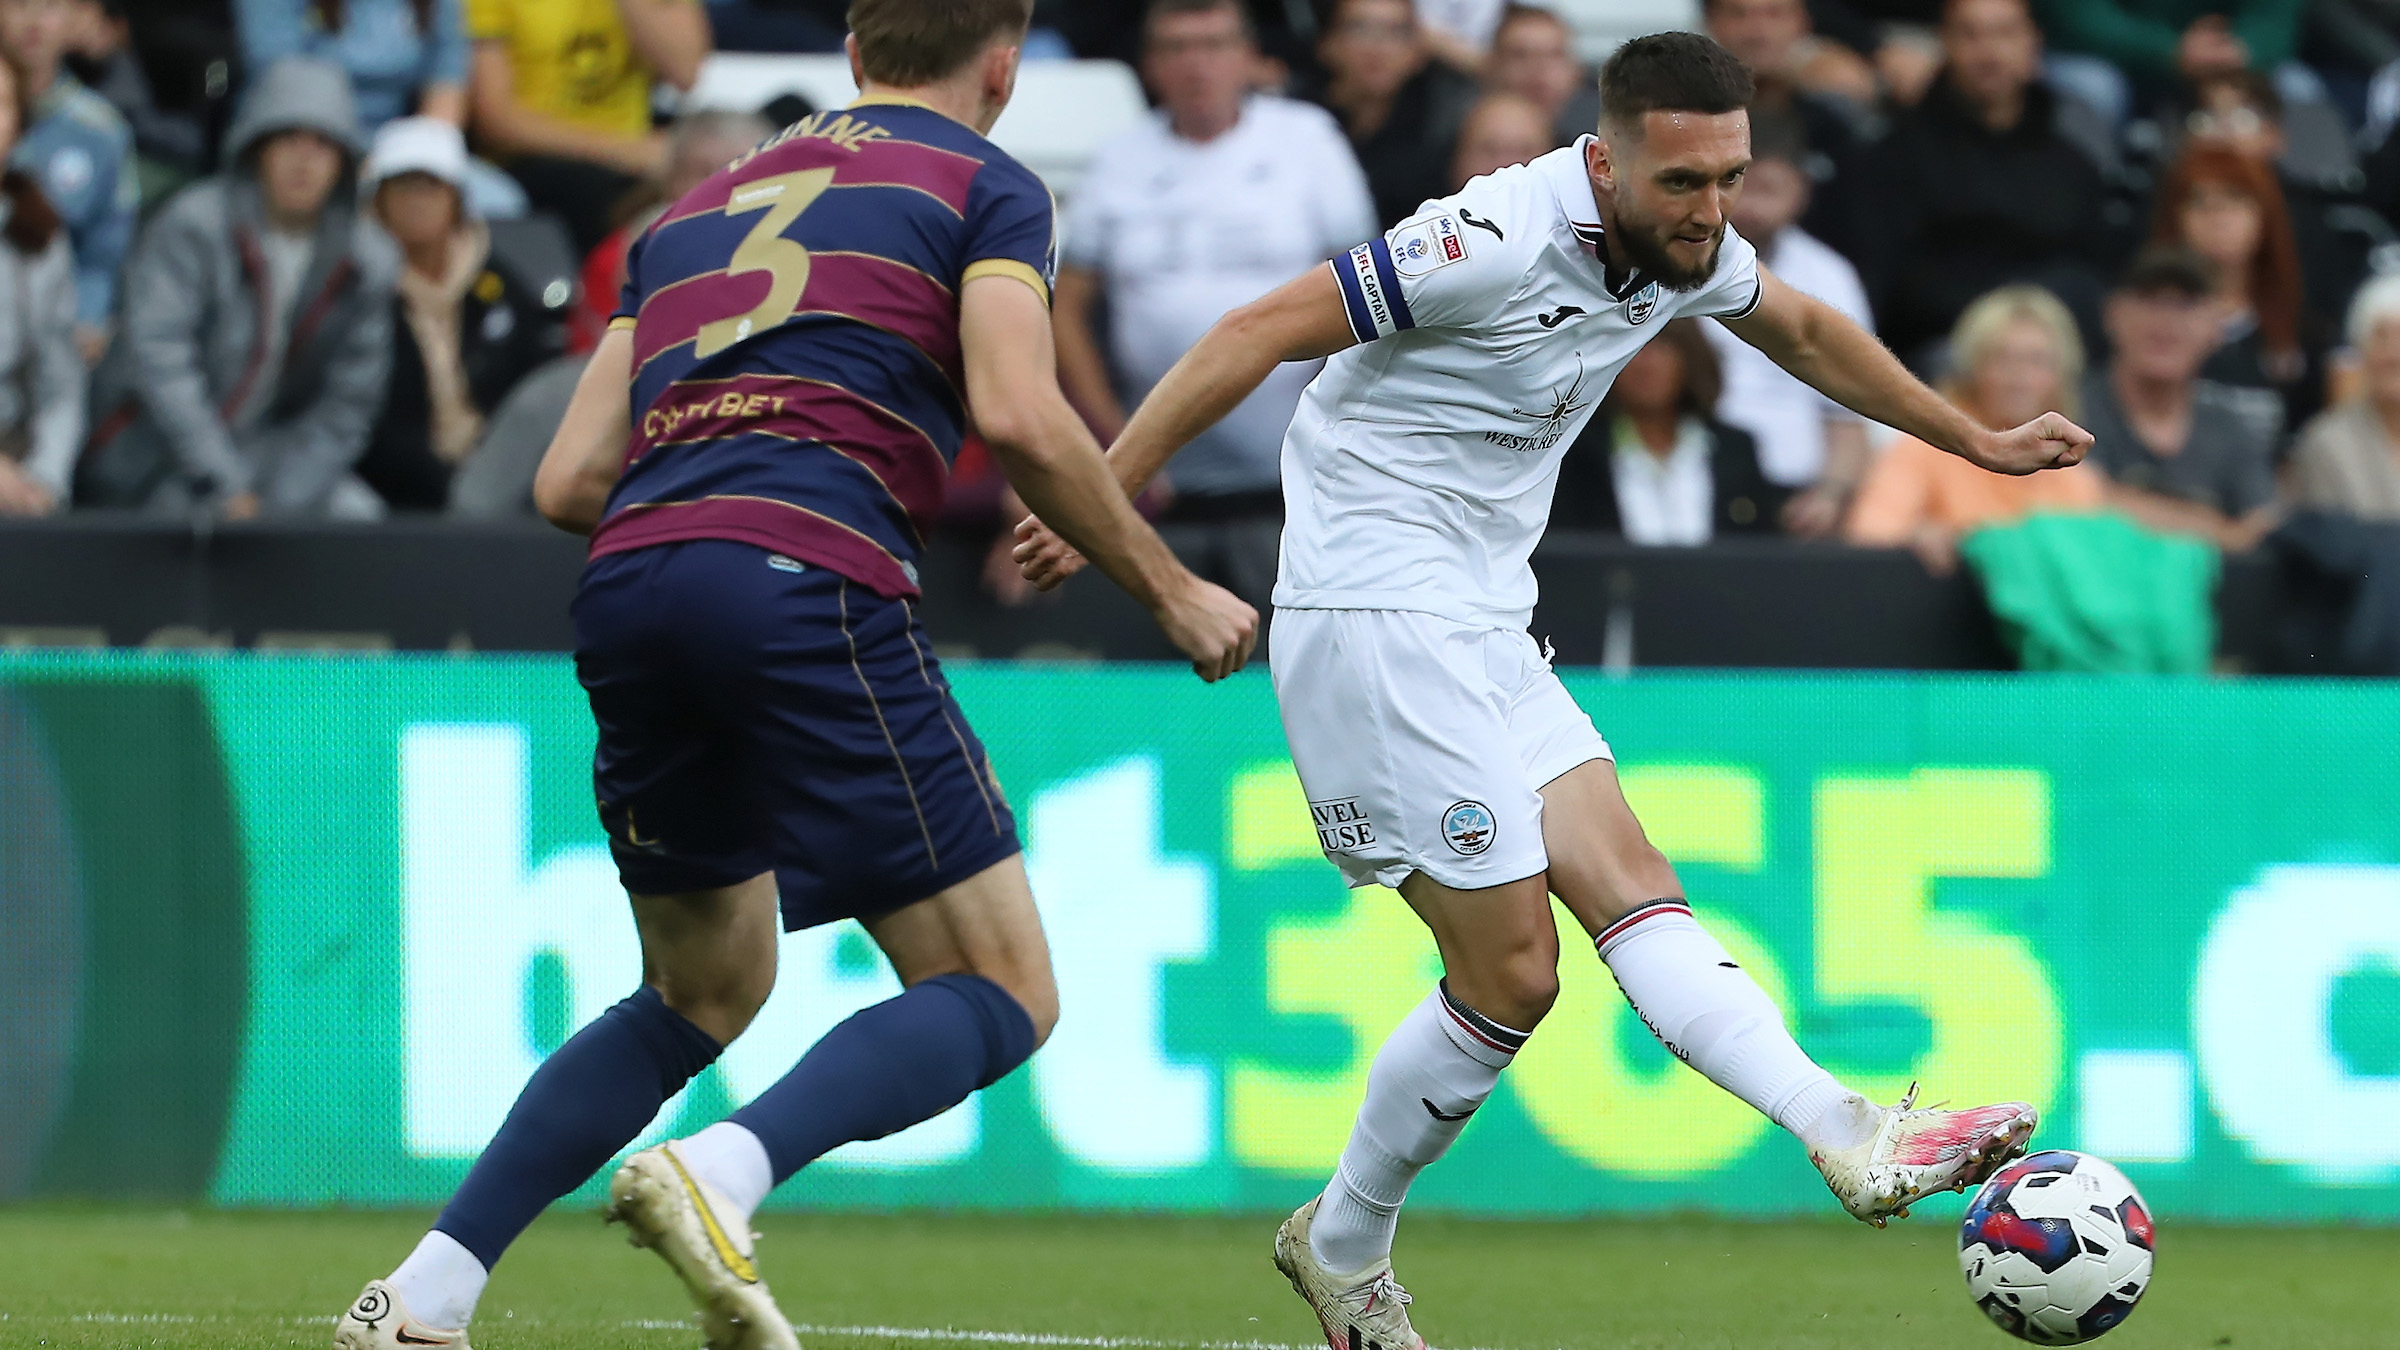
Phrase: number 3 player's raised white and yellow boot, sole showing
[{"left": 607, "top": 1143, "right": 799, "bottom": 1350}]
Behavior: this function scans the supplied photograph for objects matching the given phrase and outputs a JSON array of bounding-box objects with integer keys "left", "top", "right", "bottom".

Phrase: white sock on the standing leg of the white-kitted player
[{"left": 1308, "top": 982, "right": 1526, "bottom": 1273}]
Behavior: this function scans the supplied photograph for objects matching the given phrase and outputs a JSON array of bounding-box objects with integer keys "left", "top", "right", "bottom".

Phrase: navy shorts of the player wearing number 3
[{"left": 574, "top": 540, "right": 1020, "bottom": 930}]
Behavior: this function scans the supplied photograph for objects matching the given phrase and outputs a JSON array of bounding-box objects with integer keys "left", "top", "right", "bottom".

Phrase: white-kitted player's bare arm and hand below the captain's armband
[{"left": 1015, "top": 267, "right": 1358, "bottom": 591}]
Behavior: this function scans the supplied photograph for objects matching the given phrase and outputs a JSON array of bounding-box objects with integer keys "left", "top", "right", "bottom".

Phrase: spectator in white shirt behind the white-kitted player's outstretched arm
[{"left": 1699, "top": 119, "right": 1881, "bottom": 538}]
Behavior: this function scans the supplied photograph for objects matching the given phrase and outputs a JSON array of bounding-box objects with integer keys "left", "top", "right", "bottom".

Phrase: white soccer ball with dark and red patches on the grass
[{"left": 1958, "top": 1148, "right": 2155, "bottom": 1345}]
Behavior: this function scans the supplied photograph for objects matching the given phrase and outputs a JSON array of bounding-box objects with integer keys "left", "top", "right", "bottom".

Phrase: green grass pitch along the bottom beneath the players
[{"left": 0, "top": 1208, "right": 2400, "bottom": 1350}]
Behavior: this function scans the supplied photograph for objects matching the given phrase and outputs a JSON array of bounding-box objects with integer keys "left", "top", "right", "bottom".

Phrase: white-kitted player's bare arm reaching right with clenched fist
[{"left": 1723, "top": 267, "right": 2093, "bottom": 473}]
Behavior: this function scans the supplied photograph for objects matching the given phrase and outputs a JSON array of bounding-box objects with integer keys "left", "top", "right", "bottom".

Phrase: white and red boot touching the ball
[{"left": 1807, "top": 1083, "right": 2040, "bottom": 1227}]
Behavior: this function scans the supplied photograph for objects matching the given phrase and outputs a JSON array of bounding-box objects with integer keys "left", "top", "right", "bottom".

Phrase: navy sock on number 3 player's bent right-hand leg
[{"left": 727, "top": 975, "right": 1034, "bottom": 1187}]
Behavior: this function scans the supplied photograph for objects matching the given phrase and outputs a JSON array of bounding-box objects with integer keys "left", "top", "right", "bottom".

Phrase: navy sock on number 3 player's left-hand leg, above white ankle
[{"left": 434, "top": 987, "right": 722, "bottom": 1271}]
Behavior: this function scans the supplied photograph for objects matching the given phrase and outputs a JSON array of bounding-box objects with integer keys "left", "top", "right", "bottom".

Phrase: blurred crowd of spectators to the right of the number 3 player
[{"left": 994, "top": 0, "right": 2400, "bottom": 662}]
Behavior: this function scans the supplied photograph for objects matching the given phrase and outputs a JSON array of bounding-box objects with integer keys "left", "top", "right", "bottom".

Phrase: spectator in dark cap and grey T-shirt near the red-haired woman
[{"left": 2083, "top": 247, "right": 2282, "bottom": 550}]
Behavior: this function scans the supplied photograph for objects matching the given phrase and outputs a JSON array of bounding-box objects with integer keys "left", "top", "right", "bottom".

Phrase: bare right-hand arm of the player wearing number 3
[{"left": 958, "top": 276, "right": 1258, "bottom": 680}]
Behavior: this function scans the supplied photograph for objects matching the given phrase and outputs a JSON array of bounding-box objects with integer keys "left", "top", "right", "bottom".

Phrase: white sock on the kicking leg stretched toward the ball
[{"left": 1594, "top": 901, "right": 1874, "bottom": 1148}]
